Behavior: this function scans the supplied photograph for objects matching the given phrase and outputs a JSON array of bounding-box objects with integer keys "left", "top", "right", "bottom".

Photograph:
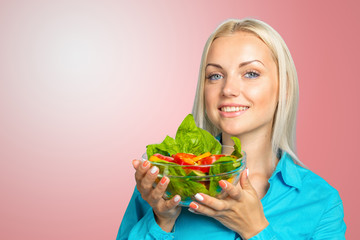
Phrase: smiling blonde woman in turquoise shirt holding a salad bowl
[{"left": 117, "top": 19, "right": 346, "bottom": 240}]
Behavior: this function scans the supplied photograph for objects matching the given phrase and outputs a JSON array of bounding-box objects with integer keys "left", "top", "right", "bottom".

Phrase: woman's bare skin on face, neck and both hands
[{"left": 133, "top": 32, "right": 278, "bottom": 239}]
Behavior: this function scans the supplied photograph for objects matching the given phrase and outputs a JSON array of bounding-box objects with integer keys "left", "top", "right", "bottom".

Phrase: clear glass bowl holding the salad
[{"left": 142, "top": 145, "right": 246, "bottom": 206}]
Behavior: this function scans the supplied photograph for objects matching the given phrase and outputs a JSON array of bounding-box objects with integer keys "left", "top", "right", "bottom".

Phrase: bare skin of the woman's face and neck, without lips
[{"left": 204, "top": 32, "right": 279, "bottom": 201}]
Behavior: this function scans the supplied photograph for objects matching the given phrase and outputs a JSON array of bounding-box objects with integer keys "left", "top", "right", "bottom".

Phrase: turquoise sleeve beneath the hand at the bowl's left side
[{"left": 116, "top": 188, "right": 174, "bottom": 240}]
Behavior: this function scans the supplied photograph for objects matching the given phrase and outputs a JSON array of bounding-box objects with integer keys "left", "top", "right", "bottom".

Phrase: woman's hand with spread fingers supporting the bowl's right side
[{"left": 189, "top": 169, "right": 269, "bottom": 239}]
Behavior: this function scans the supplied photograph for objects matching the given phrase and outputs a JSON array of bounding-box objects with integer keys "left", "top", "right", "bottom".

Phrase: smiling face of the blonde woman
[{"left": 204, "top": 32, "right": 278, "bottom": 136}]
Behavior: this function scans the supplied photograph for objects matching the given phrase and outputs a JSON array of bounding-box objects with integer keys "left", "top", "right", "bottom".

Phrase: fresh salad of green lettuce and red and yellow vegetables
[{"left": 146, "top": 114, "right": 244, "bottom": 201}]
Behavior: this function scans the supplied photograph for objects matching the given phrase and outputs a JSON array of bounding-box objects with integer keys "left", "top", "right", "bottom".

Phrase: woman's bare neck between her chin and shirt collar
[{"left": 222, "top": 130, "right": 278, "bottom": 178}]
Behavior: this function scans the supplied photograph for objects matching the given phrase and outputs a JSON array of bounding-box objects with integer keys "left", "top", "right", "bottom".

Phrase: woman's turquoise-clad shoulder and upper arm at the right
[{"left": 263, "top": 154, "right": 345, "bottom": 239}]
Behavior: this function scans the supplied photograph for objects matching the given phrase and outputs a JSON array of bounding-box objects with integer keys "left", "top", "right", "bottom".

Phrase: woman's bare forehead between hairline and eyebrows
[{"left": 206, "top": 32, "right": 274, "bottom": 65}]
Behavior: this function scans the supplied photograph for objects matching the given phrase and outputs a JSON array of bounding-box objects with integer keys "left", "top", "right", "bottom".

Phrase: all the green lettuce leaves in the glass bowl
[{"left": 146, "top": 114, "right": 242, "bottom": 200}]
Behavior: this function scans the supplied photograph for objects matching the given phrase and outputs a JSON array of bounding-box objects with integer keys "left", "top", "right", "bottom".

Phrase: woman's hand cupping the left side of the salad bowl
[{"left": 132, "top": 160, "right": 181, "bottom": 232}]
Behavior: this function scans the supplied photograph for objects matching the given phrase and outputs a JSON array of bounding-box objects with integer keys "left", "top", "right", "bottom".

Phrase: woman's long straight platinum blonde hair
[{"left": 192, "top": 19, "right": 303, "bottom": 165}]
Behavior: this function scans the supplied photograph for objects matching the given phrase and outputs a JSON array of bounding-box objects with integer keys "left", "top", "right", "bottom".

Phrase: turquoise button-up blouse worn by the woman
[{"left": 116, "top": 152, "right": 346, "bottom": 240}]
